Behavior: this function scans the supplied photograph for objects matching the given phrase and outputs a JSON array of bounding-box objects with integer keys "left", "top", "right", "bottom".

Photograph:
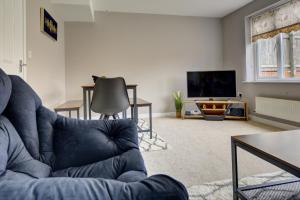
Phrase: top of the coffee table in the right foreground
[{"left": 232, "top": 130, "right": 300, "bottom": 176}]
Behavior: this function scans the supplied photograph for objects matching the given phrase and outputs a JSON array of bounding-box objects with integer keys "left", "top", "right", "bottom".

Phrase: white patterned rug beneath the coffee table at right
[{"left": 188, "top": 171, "right": 295, "bottom": 200}]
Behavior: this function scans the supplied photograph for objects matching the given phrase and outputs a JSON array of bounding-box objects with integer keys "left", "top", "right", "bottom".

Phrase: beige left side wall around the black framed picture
[{"left": 26, "top": 0, "right": 66, "bottom": 108}]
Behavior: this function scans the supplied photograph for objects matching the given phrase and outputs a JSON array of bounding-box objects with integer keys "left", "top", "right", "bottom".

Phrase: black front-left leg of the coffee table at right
[{"left": 231, "top": 139, "right": 239, "bottom": 200}]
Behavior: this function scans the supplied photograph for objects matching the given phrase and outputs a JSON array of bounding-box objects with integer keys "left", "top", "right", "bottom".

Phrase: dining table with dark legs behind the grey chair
[{"left": 81, "top": 84, "right": 138, "bottom": 124}]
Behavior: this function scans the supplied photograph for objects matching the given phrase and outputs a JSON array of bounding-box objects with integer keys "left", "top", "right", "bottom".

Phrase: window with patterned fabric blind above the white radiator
[{"left": 246, "top": 0, "right": 300, "bottom": 81}]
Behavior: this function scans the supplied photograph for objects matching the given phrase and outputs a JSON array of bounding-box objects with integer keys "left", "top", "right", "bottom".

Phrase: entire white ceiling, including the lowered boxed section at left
[{"left": 51, "top": 0, "right": 253, "bottom": 22}]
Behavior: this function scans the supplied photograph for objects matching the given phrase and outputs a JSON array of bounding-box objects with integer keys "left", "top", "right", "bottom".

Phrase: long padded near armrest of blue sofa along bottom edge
[{"left": 0, "top": 175, "right": 188, "bottom": 200}]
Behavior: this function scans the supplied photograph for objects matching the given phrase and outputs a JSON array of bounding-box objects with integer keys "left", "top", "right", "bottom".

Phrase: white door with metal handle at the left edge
[{"left": 0, "top": 0, "right": 26, "bottom": 80}]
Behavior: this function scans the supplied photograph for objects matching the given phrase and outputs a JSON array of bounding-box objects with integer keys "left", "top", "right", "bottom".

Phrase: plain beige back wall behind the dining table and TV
[{"left": 65, "top": 12, "right": 223, "bottom": 112}]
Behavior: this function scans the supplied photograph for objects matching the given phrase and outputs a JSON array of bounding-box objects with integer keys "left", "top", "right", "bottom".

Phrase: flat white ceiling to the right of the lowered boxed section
[{"left": 94, "top": 0, "right": 253, "bottom": 17}]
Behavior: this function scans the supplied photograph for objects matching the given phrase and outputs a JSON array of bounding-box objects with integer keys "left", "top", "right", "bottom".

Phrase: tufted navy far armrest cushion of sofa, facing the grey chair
[{"left": 53, "top": 116, "right": 139, "bottom": 170}]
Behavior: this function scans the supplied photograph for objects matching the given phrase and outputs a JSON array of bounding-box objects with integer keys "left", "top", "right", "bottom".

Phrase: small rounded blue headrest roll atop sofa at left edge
[{"left": 0, "top": 68, "right": 12, "bottom": 114}]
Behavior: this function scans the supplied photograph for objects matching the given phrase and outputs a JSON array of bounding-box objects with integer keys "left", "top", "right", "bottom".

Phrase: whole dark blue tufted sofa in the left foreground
[{"left": 0, "top": 69, "right": 188, "bottom": 200}]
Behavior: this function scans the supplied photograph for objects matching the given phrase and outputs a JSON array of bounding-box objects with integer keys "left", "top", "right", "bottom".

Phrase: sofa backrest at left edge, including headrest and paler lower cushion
[{"left": 0, "top": 68, "right": 51, "bottom": 178}]
